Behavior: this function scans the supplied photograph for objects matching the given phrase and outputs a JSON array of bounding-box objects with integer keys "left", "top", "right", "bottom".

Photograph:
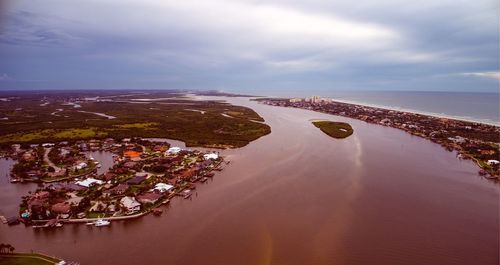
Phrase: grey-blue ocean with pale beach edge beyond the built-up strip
[{"left": 318, "top": 91, "right": 500, "bottom": 125}]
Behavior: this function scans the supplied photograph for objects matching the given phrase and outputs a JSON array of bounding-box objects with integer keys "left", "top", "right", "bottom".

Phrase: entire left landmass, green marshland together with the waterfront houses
[{"left": 0, "top": 91, "right": 271, "bottom": 228}]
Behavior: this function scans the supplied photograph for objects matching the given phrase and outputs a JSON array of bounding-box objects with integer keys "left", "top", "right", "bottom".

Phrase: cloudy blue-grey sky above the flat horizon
[{"left": 0, "top": 0, "right": 500, "bottom": 94}]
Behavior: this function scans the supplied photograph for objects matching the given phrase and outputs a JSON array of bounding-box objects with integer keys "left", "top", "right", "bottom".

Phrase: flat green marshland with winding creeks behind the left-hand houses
[{"left": 0, "top": 91, "right": 271, "bottom": 148}]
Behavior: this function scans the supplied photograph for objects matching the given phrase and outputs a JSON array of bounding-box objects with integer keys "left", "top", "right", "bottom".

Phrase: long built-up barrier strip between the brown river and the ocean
[{"left": 255, "top": 96, "right": 500, "bottom": 181}]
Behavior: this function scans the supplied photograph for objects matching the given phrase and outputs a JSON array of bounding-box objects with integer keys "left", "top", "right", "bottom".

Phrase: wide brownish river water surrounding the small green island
[{"left": 0, "top": 98, "right": 499, "bottom": 265}]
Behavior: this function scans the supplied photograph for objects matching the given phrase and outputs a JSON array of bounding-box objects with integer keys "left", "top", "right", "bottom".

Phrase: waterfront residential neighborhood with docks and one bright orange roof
[{"left": 0, "top": 138, "right": 223, "bottom": 227}]
